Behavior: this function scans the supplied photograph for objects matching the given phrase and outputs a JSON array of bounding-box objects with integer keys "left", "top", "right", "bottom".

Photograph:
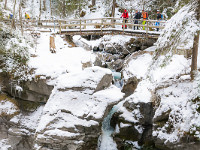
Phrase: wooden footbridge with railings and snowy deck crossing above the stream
[{"left": 4, "top": 17, "right": 165, "bottom": 38}]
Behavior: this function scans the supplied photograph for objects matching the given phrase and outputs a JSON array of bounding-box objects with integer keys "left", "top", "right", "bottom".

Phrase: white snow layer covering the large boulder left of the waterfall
[{"left": 37, "top": 67, "right": 124, "bottom": 138}]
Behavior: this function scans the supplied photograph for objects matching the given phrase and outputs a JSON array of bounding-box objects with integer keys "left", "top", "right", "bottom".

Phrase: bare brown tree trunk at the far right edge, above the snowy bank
[{"left": 191, "top": 0, "right": 200, "bottom": 80}]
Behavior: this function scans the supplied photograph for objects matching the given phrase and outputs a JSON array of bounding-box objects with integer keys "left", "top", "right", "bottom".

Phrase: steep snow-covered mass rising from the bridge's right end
[{"left": 157, "top": 1, "right": 200, "bottom": 56}]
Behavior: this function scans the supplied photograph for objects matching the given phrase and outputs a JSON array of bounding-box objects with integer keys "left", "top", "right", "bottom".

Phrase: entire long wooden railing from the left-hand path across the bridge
[{"left": 4, "top": 17, "right": 165, "bottom": 33}]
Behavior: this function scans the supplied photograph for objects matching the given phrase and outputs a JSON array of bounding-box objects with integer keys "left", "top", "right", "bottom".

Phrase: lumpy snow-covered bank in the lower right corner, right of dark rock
[{"left": 153, "top": 78, "right": 200, "bottom": 143}]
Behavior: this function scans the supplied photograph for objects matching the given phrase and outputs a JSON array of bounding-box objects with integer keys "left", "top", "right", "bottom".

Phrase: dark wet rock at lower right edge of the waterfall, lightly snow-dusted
[{"left": 111, "top": 101, "right": 154, "bottom": 149}]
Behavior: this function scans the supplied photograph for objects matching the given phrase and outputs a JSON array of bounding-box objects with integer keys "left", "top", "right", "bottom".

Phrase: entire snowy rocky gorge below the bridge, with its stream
[{"left": 0, "top": 1, "right": 200, "bottom": 150}]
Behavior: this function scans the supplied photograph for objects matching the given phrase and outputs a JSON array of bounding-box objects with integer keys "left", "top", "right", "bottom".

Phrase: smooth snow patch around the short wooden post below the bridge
[{"left": 29, "top": 33, "right": 95, "bottom": 78}]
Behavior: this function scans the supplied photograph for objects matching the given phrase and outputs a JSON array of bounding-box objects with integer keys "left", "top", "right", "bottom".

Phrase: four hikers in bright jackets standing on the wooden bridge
[{"left": 121, "top": 9, "right": 163, "bottom": 31}]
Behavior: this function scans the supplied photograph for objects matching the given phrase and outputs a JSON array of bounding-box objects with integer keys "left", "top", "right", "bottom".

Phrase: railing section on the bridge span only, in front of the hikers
[{"left": 60, "top": 18, "right": 165, "bottom": 32}]
